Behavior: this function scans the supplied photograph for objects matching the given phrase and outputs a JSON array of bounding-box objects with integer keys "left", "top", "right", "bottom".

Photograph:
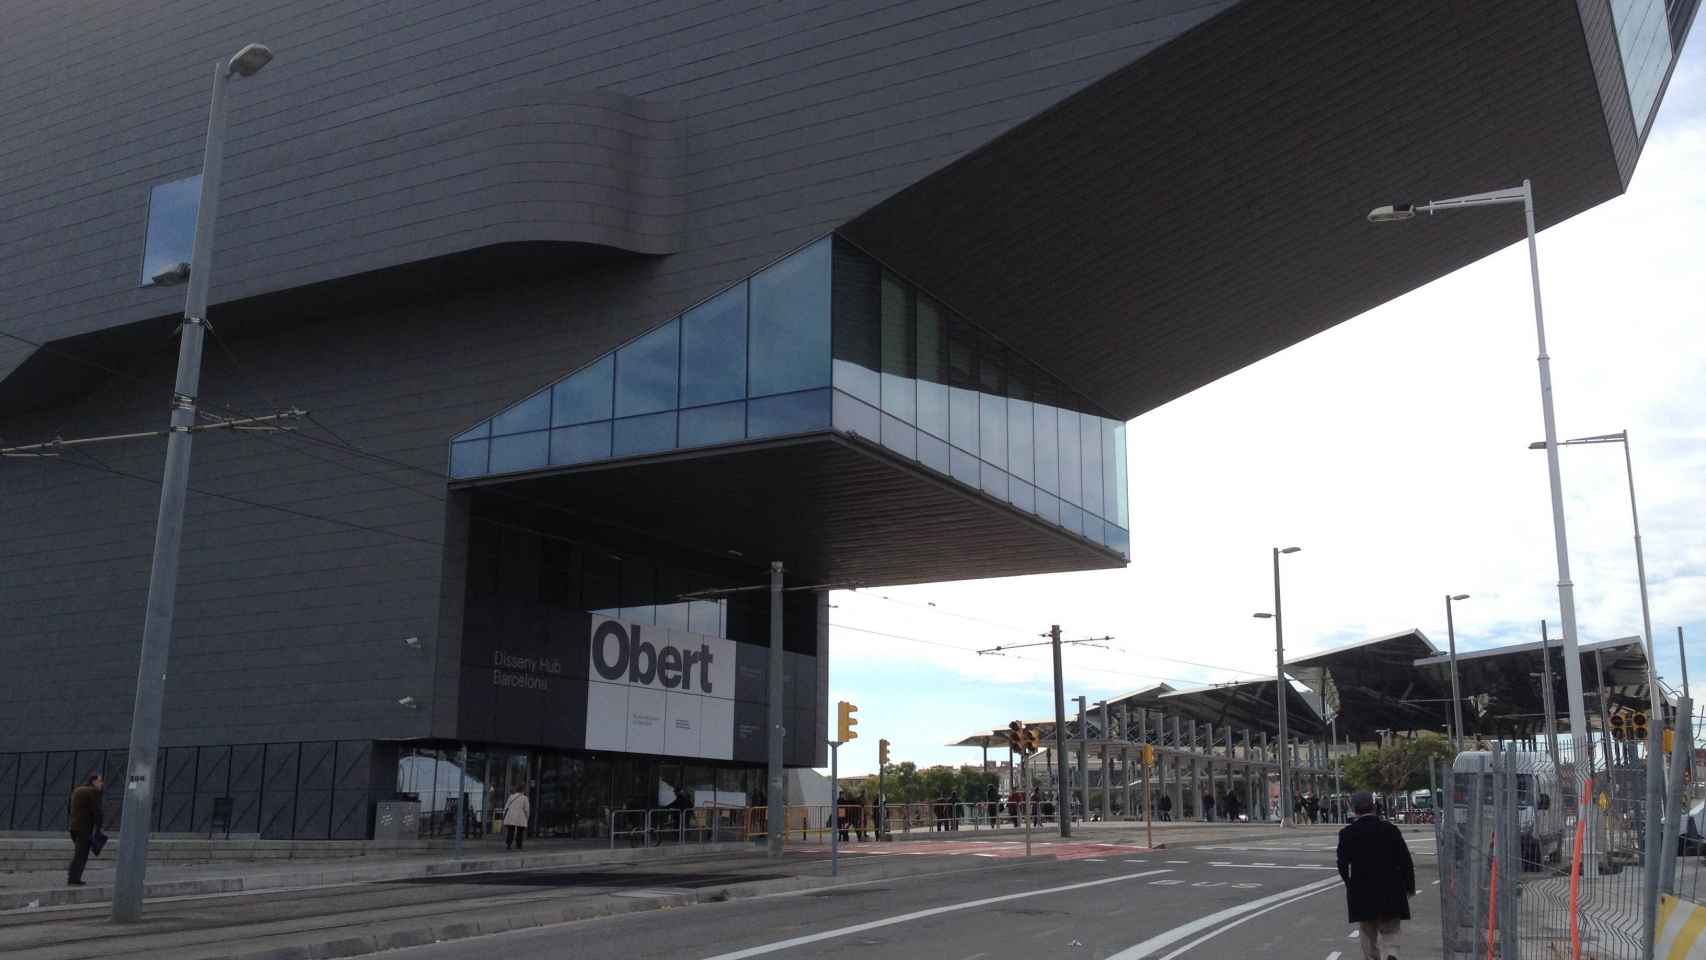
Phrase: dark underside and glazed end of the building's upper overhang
[{"left": 844, "top": 0, "right": 1694, "bottom": 418}]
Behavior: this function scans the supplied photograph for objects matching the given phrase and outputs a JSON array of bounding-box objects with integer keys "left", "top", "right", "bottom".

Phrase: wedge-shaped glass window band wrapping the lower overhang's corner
[{"left": 450, "top": 237, "right": 1131, "bottom": 558}]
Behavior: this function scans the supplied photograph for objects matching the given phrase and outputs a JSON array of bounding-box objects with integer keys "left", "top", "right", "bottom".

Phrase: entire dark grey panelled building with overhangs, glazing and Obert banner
[{"left": 0, "top": 0, "right": 1694, "bottom": 837}]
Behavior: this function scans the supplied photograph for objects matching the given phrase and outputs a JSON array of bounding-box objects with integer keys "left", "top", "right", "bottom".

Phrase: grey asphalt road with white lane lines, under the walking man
[{"left": 377, "top": 830, "right": 1438, "bottom": 960}]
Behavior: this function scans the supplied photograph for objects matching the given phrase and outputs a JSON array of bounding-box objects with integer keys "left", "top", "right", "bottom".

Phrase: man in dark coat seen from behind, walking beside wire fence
[{"left": 1339, "top": 791, "right": 1416, "bottom": 960}]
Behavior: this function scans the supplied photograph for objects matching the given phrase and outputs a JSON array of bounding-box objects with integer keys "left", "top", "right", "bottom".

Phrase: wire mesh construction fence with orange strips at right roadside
[{"left": 1435, "top": 699, "right": 1706, "bottom": 960}]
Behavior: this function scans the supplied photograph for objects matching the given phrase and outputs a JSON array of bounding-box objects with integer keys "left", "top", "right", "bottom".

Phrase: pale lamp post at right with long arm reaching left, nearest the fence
[{"left": 1368, "top": 181, "right": 1588, "bottom": 835}]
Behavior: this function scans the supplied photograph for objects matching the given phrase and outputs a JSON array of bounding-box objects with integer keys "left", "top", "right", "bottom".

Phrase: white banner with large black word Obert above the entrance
[{"left": 587, "top": 616, "right": 735, "bottom": 760}]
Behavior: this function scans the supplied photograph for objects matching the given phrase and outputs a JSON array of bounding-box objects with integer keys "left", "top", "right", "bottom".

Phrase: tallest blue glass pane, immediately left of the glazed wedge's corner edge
[{"left": 747, "top": 237, "right": 831, "bottom": 399}]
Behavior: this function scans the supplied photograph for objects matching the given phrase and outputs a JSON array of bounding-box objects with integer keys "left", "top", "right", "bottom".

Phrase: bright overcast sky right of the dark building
[{"left": 829, "top": 31, "right": 1706, "bottom": 774}]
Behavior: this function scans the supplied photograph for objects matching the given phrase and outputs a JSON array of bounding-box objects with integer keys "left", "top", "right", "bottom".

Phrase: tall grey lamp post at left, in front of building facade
[{"left": 113, "top": 43, "right": 273, "bottom": 922}]
